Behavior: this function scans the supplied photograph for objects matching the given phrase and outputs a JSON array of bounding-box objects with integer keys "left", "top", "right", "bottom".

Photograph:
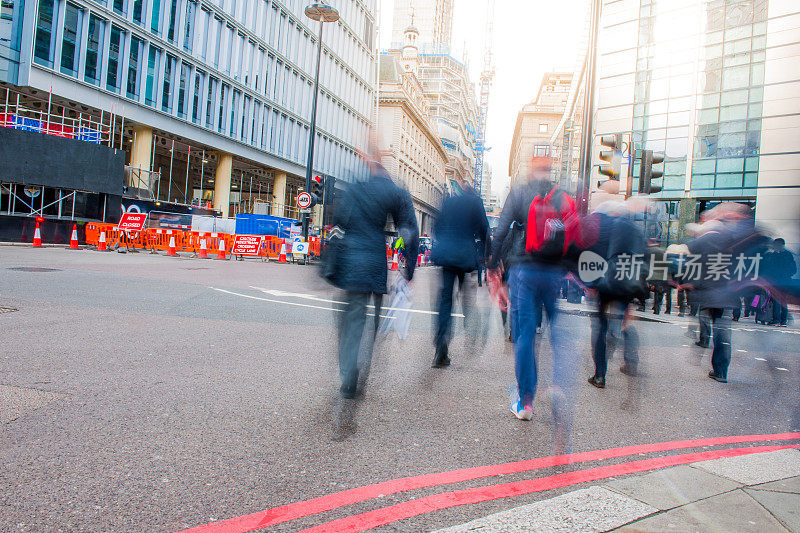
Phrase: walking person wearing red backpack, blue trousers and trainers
[{"left": 488, "top": 157, "right": 577, "bottom": 436}]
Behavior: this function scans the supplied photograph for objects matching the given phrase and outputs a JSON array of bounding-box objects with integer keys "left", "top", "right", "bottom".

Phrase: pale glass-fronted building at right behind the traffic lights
[{"left": 593, "top": 0, "right": 800, "bottom": 243}]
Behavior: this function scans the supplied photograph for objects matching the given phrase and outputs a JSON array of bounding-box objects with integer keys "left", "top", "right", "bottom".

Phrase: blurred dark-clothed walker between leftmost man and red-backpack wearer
[{"left": 432, "top": 181, "right": 489, "bottom": 368}]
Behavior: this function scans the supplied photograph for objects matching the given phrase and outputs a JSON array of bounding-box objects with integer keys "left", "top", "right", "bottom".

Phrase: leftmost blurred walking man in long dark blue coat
[{"left": 333, "top": 161, "right": 419, "bottom": 398}]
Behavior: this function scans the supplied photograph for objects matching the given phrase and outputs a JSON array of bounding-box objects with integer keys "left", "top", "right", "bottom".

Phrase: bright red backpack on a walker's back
[{"left": 525, "top": 188, "right": 580, "bottom": 258}]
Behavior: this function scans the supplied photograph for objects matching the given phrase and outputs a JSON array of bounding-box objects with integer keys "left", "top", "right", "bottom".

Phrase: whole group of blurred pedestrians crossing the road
[{"left": 322, "top": 145, "right": 800, "bottom": 444}]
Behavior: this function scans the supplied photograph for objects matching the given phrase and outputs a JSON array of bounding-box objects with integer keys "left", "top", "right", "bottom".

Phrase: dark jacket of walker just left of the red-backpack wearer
[{"left": 431, "top": 187, "right": 489, "bottom": 272}]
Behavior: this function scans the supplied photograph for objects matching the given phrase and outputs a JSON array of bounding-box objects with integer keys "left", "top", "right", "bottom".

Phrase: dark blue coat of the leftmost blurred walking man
[{"left": 334, "top": 168, "right": 419, "bottom": 294}]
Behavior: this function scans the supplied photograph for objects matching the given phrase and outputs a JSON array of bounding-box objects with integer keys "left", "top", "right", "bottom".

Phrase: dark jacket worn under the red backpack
[{"left": 487, "top": 180, "right": 560, "bottom": 268}]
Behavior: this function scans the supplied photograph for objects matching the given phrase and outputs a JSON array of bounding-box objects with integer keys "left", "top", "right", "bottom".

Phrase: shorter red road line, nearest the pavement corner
[{"left": 300, "top": 445, "right": 798, "bottom": 533}]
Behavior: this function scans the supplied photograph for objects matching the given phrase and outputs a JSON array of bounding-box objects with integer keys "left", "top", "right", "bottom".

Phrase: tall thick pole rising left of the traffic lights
[{"left": 578, "top": 0, "right": 602, "bottom": 215}]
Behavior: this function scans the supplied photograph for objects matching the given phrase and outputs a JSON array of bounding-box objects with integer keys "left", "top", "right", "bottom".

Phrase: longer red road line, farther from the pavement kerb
[{"left": 178, "top": 433, "right": 800, "bottom": 533}]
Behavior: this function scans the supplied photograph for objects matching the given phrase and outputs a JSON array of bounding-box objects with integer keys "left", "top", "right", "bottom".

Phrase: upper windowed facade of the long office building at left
[{"left": 0, "top": 0, "right": 377, "bottom": 218}]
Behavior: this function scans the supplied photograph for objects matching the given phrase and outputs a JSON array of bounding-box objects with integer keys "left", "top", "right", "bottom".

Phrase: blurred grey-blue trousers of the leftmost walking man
[{"left": 339, "top": 291, "right": 383, "bottom": 393}]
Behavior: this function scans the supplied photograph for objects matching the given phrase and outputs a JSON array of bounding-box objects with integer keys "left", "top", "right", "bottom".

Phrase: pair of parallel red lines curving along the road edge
[{"left": 184, "top": 433, "right": 800, "bottom": 533}]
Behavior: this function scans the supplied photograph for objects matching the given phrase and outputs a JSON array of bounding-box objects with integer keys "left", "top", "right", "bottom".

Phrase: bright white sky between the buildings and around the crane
[{"left": 378, "top": 0, "right": 590, "bottom": 194}]
